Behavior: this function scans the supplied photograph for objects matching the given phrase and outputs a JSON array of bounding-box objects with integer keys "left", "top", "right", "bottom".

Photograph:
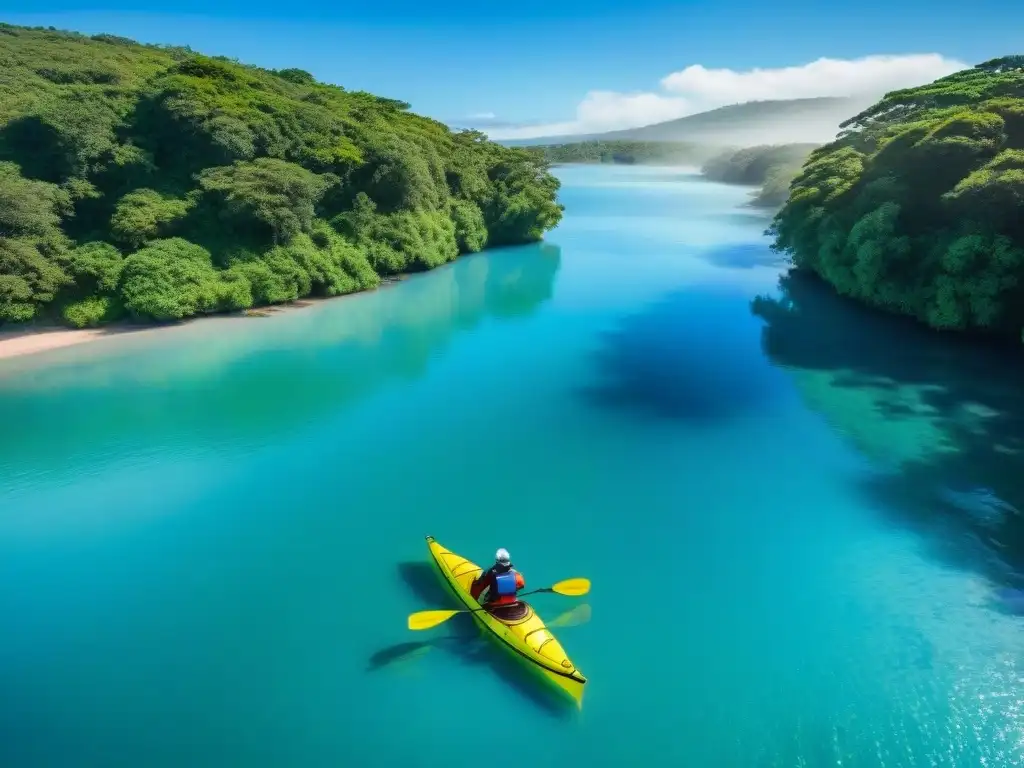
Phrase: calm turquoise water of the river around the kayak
[{"left": 0, "top": 167, "right": 1024, "bottom": 768}]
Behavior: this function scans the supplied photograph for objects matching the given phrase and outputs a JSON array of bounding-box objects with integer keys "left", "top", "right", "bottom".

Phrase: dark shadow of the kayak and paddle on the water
[{"left": 367, "top": 561, "right": 573, "bottom": 719}]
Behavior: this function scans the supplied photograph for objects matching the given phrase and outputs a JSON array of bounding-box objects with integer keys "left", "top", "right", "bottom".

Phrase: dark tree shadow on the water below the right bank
[{"left": 752, "top": 272, "right": 1024, "bottom": 585}]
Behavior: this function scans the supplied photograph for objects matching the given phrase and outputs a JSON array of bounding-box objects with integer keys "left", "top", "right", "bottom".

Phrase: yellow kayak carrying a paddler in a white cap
[{"left": 427, "top": 536, "right": 587, "bottom": 709}]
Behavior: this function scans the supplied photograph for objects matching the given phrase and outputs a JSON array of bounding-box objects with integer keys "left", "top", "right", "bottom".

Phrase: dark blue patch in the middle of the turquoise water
[{"left": 581, "top": 288, "right": 777, "bottom": 422}]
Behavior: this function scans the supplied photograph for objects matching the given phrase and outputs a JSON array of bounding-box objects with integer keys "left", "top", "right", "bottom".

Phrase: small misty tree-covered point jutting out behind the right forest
[{"left": 700, "top": 144, "right": 817, "bottom": 208}]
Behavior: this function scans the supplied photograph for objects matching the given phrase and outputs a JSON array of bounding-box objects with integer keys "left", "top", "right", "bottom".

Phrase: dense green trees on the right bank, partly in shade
[{"left": 771, "top": 56, "right": 1024, "bottom": 339}]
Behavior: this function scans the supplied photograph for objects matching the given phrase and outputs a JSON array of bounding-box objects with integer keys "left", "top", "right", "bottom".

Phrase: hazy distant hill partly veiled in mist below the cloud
[{"left": 501, "top": 97, "right": 874, "bottom": 146}]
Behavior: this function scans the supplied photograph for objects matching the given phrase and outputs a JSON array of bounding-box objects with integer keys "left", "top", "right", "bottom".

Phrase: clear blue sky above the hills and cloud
[{"left": 0, "top": 0, "right": 1024, "bottom": 137}]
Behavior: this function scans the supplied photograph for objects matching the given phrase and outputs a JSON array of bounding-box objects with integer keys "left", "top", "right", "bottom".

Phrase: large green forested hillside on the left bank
[{"left": 0, "top": 25, "right": 562, "bottom": 327}]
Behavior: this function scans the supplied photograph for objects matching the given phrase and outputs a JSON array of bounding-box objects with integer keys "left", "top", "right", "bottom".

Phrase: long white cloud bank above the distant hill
[{"left": 487, "top": 53, "right": 969, "bottom": 138}]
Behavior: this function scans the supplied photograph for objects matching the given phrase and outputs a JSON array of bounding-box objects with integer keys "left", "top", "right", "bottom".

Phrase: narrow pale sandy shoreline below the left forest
[{"left": 0, "top": 274, "right": 409, "bottom": 361}]
